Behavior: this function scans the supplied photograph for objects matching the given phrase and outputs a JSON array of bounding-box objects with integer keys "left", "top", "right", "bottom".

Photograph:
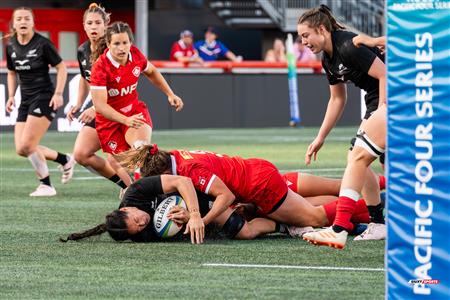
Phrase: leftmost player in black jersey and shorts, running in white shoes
[{"left": 6, "top": 7, "right": 75, "bottom": 196}]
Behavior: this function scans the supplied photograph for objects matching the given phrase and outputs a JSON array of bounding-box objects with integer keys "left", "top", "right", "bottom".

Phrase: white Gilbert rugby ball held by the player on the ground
[{"left": 153, "top": 196, "right": 186, "bottom": 238}]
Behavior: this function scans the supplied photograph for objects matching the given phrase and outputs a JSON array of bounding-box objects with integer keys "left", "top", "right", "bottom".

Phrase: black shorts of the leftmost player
[{"left": 16, "top": 93, "right": 56, "bottom": 122}]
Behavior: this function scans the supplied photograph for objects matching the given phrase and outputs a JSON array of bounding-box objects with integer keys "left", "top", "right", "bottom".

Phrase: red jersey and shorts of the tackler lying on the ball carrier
[{"left": 170, "top": 150, "right": 288, "bottom": 213}]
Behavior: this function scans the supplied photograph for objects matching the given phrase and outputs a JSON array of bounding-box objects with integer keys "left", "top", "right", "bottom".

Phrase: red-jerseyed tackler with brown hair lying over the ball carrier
[{"left": 118, "top": 145, "right": 372, "bottom": 234}]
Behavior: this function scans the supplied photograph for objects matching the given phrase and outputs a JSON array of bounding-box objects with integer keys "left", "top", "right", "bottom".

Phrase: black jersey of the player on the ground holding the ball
[{"left": 119, "top": 175, "right": 214, "bottom": 242}]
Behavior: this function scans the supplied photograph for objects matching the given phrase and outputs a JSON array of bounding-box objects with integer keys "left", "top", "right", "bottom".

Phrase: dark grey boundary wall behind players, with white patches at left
[{"left": 0, "top": 73, "right": 360, "bottom": 131}]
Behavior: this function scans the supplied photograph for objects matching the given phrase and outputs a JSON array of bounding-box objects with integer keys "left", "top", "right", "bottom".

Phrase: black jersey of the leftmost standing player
[{"left": 6, "top": 32, "right": 62, "bottom": 101}]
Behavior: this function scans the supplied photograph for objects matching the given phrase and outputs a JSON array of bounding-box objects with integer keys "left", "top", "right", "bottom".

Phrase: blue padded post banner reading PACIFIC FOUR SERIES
[{"left": 386, "top": 0, "right": 450, "bottom": 299}]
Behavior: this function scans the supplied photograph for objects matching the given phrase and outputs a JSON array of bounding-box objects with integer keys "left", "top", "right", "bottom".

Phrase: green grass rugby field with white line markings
[{"left": 0, "top": 128, "right": 384, "bottom": 299}]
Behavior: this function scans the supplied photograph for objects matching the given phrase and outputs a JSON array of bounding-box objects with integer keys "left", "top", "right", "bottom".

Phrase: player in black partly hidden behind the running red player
[{"left": 67, "top": 3, "right": 131, "bottom": 189}]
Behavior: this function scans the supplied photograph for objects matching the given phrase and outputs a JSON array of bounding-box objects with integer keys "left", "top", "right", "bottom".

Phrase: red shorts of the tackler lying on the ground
[{"left": 244, "top": 159, "right": 288, "bottom": 214}]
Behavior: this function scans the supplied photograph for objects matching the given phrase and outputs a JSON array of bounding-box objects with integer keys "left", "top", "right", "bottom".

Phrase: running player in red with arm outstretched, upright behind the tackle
[{"left": 91, "top": 22, "right": 183, "bottom": 154}]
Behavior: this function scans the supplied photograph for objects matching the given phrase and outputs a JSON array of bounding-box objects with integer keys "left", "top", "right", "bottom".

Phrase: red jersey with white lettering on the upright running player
[{"left": 91, "top": 45, "right": 148, "bottom": 113}]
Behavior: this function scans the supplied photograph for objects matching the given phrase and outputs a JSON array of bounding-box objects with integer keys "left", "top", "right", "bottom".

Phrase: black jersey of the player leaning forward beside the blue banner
[{"left": 322, "top": 30, "right": 384, "bottom": 109}]
